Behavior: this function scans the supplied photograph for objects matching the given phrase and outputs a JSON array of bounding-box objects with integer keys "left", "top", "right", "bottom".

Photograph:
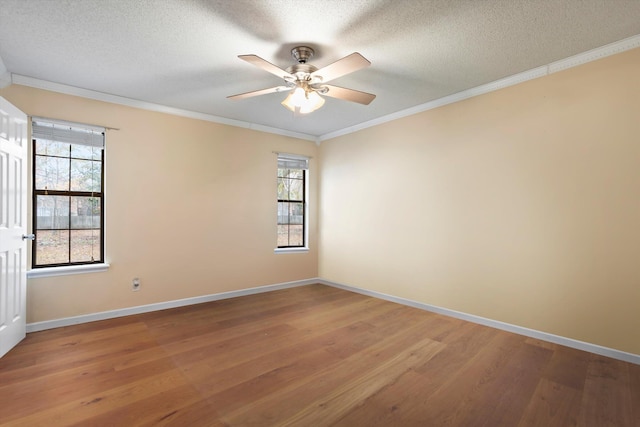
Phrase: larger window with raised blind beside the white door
[{"left": 31, "top": 118, "right": 104, "bottom": 268}]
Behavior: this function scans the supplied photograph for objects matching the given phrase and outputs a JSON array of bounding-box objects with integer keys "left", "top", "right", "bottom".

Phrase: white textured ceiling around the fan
[{"left": 0, "top": 0, "right": 640, "bottom": 137}]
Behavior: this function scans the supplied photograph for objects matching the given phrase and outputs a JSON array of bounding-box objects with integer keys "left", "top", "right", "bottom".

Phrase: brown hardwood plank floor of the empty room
[{"left": 0, "top": 285, "right": 640, "bottom": 427}]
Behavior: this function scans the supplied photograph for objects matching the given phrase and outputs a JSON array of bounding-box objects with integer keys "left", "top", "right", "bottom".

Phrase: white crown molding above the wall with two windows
[{"left": 8, "top": 75, "right": 318, "bottom": 143}]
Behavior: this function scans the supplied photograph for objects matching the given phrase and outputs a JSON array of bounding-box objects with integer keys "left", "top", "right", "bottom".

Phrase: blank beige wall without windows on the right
[{"left": 319, "top": 49, "right": 640, "bottom": 354}]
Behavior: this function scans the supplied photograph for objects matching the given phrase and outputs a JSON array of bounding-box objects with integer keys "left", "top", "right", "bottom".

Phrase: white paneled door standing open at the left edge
[{"left": 0, "top": 97, "right": 28, "bottom": 357}]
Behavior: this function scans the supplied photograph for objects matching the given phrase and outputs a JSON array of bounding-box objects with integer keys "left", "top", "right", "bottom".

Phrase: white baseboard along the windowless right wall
[{"left": 317, "top": 279, "right": 640, "bottom": 365}]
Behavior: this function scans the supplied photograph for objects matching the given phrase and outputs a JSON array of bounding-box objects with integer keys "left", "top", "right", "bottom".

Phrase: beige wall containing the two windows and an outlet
[{"left": 0, "top": 85, "right": 318, "bottom": 322}]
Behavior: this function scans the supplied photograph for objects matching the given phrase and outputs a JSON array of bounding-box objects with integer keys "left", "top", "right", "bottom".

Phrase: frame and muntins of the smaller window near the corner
[{"left": 275, "top": 153, "right": 309, "bottom": 253}]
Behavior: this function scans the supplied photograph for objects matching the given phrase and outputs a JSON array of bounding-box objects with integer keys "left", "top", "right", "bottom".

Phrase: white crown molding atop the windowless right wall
[{"left": 318, "top": 35, "right": 640, "bottom": 144}]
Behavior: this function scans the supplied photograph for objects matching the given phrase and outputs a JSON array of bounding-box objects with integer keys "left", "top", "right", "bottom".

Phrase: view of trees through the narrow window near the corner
[{"left": 278, "top": 168, "right": 306, "bottom": 248}]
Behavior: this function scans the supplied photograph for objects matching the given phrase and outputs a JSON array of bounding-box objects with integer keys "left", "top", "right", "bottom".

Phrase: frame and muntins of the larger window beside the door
[{"left": 30, "top": 117, "right": 108, "bottom": 270}]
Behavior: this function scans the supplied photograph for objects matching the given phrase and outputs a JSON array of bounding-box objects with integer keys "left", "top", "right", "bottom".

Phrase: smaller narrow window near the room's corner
[{"left": 278, "top": 154, "right": 308, "bottom": 248}]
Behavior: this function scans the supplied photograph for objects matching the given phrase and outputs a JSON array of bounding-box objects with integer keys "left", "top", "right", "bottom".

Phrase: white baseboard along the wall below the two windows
[{"left": 27, "top": 278, "right": 320, "bottom": 333}]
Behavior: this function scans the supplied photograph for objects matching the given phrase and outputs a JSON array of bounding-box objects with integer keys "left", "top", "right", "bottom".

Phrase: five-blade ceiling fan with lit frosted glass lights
[{"left": 227, "top": 46, "right": 376, "bottom": 114}]
